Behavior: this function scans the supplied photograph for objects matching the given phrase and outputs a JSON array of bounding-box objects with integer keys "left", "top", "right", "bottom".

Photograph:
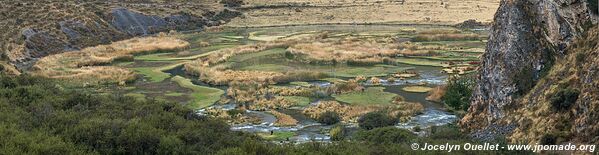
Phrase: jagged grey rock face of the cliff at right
[{"left": 460, "top": 0, "right": 591, "bottom": 140}]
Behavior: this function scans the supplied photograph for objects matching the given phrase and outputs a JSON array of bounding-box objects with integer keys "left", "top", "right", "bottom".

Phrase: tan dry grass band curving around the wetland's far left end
[{"left": 32, "top": 36, "right": 189, "bottom": 83}]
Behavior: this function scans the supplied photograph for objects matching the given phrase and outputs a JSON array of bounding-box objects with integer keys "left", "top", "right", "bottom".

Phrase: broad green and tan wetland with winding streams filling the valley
[{"left": 41, "top": 25, "right": 487, "bottom": 142}]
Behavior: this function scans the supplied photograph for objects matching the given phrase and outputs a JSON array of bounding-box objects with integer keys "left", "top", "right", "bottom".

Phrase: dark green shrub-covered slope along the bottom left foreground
[{"left": 0, "top": 74, "right": 524, "bottom": 155}]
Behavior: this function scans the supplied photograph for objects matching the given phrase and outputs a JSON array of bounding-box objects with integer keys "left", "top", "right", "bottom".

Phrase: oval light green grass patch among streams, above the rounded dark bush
[{"left": 333, "top": 87, "right": 397, "bottom": 105}]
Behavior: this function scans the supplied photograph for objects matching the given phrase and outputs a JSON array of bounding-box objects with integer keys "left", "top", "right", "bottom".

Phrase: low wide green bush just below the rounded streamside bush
[{"left": 354, "top": 127, "right": 416, "bottom": 144}]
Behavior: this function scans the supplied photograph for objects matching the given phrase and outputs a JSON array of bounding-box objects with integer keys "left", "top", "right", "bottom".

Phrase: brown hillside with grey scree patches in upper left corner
[{"left": 0, "top": 0, "right": 240, "bottom": 70}]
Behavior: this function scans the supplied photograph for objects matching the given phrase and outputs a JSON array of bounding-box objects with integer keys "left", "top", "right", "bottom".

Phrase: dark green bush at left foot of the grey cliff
[{"left": 441, "top": 77, "right": 474, "bottom": 110}]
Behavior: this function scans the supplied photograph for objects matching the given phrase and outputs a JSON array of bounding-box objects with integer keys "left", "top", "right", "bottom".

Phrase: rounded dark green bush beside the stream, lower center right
[{"left": 358, "top": 111, "right": 397, "bottom": 130}]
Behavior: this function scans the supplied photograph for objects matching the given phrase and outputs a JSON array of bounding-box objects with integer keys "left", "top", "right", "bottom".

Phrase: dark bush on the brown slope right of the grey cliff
[{"left": 550, "top": 88, "right": 580, "bottom": 111}]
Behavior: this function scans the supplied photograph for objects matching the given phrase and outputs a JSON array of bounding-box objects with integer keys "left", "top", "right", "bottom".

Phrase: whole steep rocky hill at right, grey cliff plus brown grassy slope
[{"left": 461, "top": 0, "right": 599, "bottom": 142}]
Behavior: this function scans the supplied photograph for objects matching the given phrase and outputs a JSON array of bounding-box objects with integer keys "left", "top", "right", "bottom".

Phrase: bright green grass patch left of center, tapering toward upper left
[{"left": 171, "top": 76, "right": 225, "bottom": 109}]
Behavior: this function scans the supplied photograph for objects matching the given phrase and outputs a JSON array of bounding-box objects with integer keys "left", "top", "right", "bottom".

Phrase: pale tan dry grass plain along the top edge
[{"left": 228, "top": 0, "right": 499, "bottom": 27}]
